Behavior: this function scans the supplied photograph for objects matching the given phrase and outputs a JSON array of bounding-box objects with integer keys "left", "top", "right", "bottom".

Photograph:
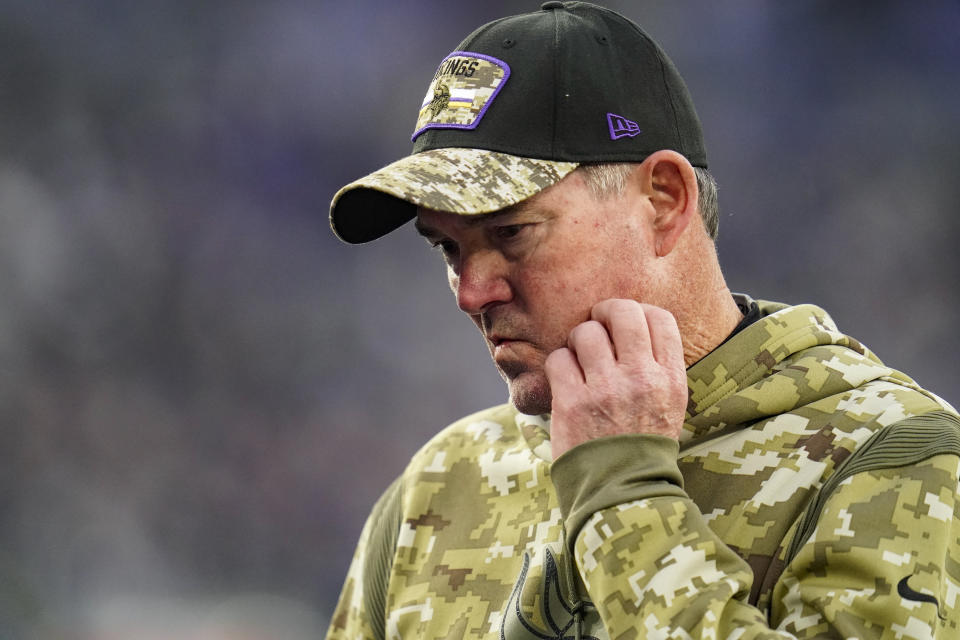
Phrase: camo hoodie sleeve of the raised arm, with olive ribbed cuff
[{"left": 552, "top": 435, "right": 960, "bottom": 639}]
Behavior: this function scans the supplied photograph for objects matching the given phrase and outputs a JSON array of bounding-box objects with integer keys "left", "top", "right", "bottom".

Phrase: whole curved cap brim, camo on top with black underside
[{"left": 330, "top": 148, "right": 578, "bottom": 244}]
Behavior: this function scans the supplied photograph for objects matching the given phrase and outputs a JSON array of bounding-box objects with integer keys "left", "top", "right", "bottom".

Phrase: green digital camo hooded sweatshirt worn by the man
[{"left": 328, "top": 303, "right": 960, "bottom": 640}]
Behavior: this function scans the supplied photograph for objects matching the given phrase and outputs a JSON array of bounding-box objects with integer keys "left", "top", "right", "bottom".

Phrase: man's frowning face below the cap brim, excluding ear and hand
[{"left": 416, "top": 171, "right": 657, "bottom": 414}]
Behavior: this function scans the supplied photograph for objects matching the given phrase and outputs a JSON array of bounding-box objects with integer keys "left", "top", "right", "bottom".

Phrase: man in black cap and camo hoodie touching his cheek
[{"left": 329, "top": 2, "right": 960, "bottom": 640}]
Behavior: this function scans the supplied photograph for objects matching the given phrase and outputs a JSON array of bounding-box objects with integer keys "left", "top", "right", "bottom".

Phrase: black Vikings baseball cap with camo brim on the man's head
[{"left": 330, "top": 1, "right": 707, "bottom": 243}]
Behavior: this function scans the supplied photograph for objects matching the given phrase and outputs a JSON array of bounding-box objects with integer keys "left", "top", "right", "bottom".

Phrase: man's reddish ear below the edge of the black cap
[{"left": 634, "top": 149, "right": 699, "bottom": 258}]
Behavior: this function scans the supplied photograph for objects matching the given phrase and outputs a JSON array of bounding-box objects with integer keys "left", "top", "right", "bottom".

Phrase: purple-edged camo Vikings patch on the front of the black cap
[{"left": 412, "top": 51, "right": 510, "bottom": 140}]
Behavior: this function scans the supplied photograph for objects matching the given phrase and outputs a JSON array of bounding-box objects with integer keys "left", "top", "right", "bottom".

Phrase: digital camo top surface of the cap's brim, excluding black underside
[{"left": 330, "top": 147, "right": 577, "bottom": 221}]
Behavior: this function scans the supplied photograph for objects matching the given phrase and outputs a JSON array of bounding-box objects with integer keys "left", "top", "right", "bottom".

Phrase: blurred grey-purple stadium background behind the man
[{"left": 0, "top": 0, "right": 960, "bottom": 640}]
